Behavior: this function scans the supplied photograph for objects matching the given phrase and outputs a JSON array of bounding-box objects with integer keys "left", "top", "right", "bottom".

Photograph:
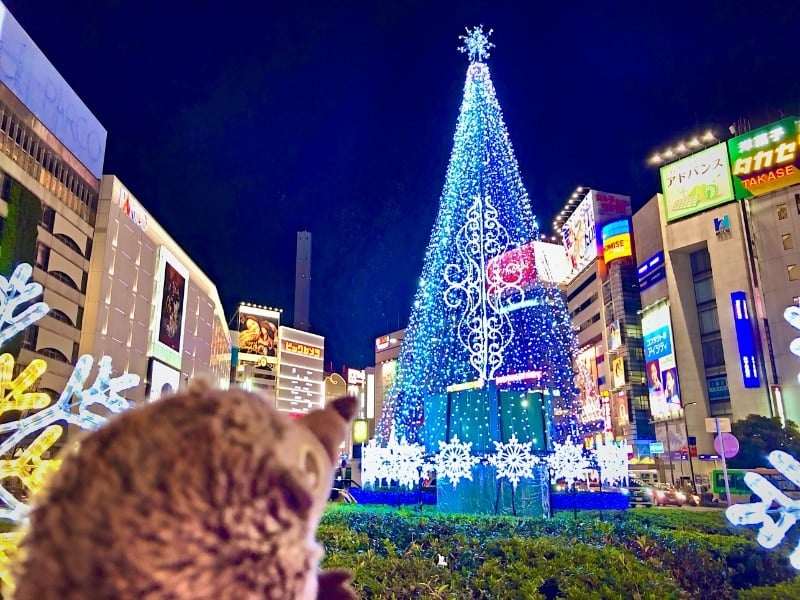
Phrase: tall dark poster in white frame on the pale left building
[{"left": 150, "top": 246, "right": 189, "bottom": 369}]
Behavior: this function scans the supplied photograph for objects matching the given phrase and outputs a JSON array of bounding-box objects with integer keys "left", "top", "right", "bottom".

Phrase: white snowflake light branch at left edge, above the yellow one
[{"left": 0, "top": 263, "right": 50, "bottom": 346}]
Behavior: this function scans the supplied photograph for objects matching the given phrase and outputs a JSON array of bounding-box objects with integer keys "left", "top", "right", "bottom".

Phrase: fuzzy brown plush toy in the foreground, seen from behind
[{"left": 14, "top": 384, "right": 356, "bottom": 600}]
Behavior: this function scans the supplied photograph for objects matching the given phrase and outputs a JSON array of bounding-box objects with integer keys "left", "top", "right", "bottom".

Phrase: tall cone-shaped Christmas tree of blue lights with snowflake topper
[{"left": 377, "top": 28, "right": 576, "bottom": 451}]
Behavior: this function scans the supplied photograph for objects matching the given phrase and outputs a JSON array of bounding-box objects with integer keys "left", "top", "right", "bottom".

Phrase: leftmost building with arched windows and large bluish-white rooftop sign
[{"left": 0, "top": 4, "right": 106, "bottom": 398}]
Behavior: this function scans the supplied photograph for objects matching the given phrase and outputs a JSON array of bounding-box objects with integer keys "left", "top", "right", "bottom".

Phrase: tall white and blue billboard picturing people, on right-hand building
[{"left": 642, "top": 302, "right": 681, "bottom": 420}]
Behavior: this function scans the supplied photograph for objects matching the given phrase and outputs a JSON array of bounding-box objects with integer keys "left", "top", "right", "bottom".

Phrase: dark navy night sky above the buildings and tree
[{"left": 6, "top": 0, "right": 800, "bottom": 369}]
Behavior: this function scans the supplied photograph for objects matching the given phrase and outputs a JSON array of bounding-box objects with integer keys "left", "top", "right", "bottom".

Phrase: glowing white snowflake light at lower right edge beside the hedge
[{"left": 725, "top": 450, "right": 800, "bottom": 570}]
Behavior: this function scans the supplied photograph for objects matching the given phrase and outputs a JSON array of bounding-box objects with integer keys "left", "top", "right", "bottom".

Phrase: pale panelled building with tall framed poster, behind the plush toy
[{"left": 80, "top": 175, "right": 231, "bottom": 402}]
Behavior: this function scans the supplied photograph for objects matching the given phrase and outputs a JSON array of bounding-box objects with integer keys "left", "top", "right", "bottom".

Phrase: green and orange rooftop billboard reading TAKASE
[{"left": 728, "top": 117, "right": 800, "bottom": 200}]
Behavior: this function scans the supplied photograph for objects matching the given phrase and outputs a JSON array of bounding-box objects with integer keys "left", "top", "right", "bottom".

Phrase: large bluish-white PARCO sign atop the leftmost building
[{"left": 0, "top": 2, "right": 107, "bottom": 179}]
